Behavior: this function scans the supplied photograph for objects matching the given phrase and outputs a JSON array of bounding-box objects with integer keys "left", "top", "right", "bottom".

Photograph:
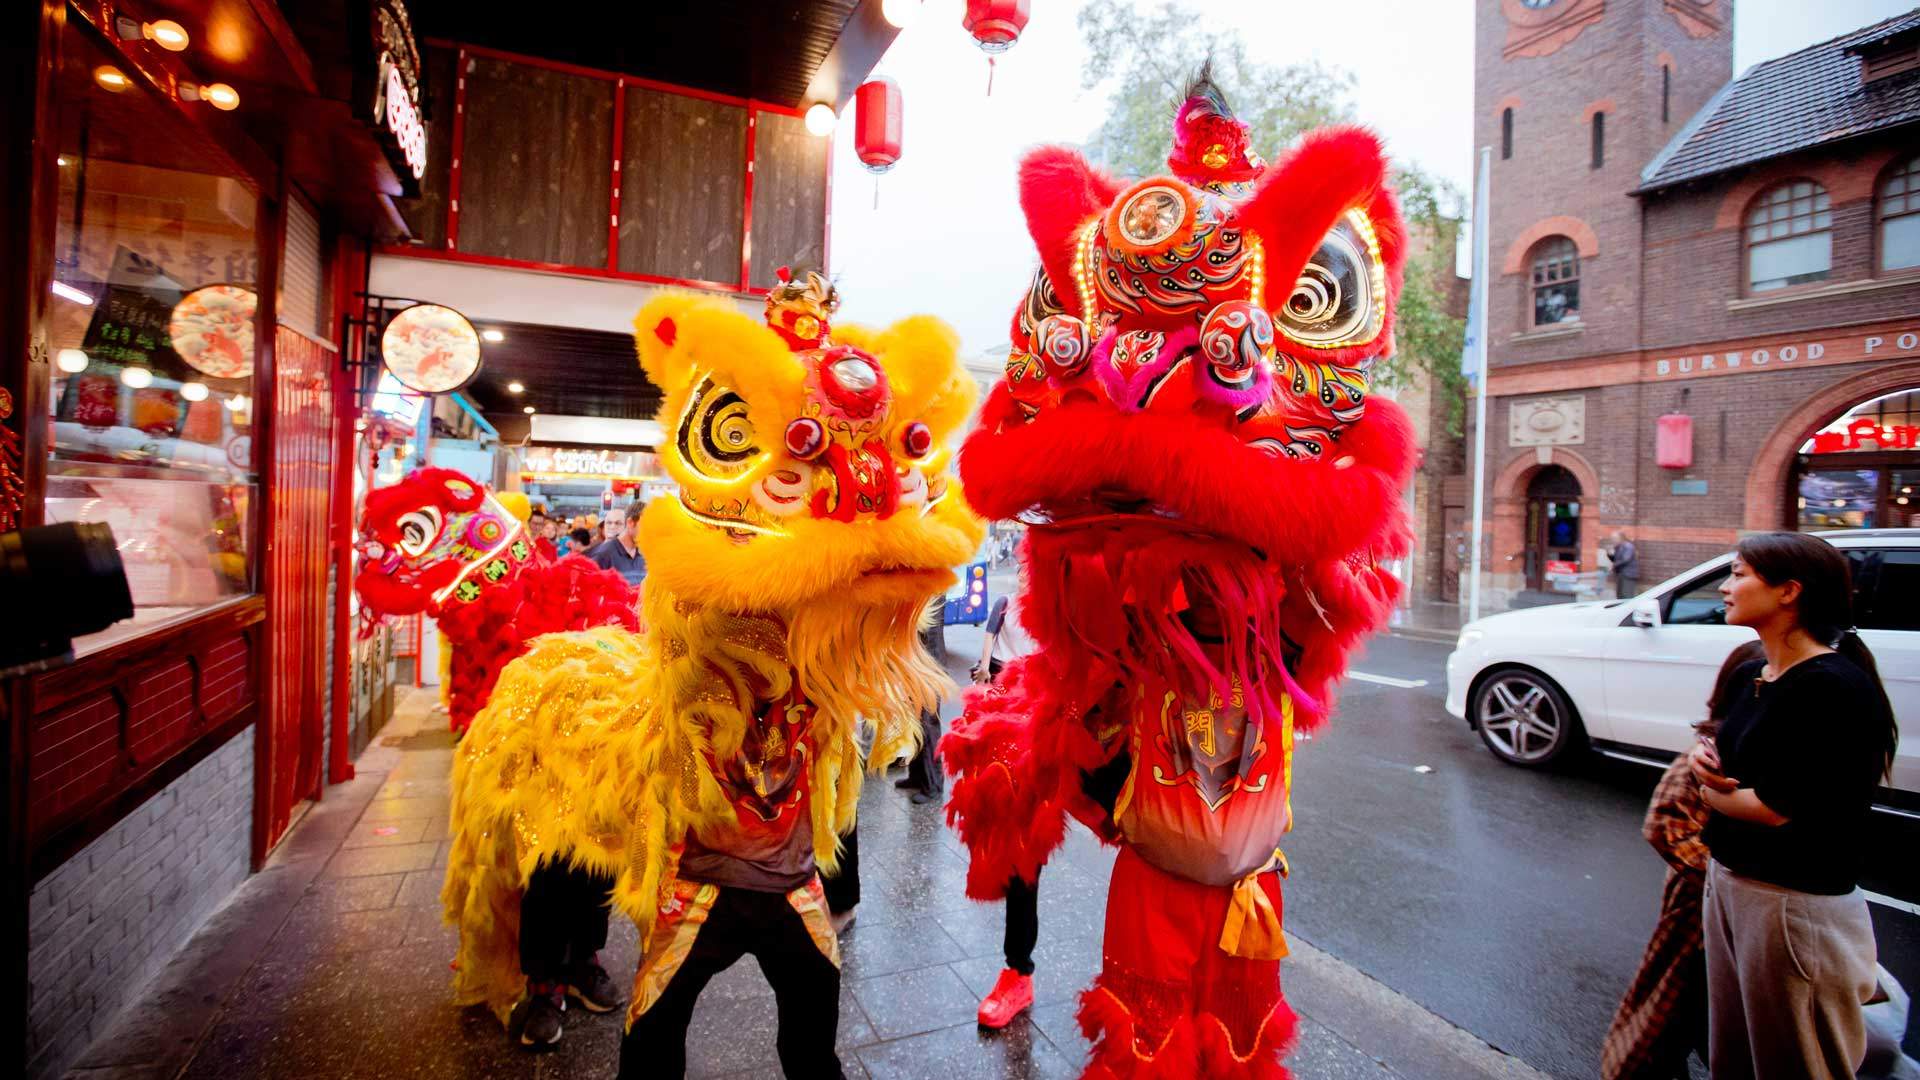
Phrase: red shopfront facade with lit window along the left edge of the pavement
[{"left": 0, "top": 0, "right": 419, "bottom": 1074}]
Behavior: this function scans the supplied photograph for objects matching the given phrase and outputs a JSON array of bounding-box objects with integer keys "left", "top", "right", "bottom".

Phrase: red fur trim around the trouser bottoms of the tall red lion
[{"left": 1079, "top": 976, "right": 1298, "bottom": 1080}]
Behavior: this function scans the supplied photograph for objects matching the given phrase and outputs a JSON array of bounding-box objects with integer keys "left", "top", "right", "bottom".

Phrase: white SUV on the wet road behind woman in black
[{"left": 1446, "top": 528, "right": 1920, "bottom": 817}]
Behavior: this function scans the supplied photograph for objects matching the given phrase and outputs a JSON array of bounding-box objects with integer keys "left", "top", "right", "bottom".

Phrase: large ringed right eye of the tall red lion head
[{"left": 1273, "top": 209, "right": 1386, "bottom": 348}]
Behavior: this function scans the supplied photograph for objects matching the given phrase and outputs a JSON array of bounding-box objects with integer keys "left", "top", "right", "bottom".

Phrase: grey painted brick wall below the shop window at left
[{"left": 25, "top": 728, "right": 253, "bottom": 1078}]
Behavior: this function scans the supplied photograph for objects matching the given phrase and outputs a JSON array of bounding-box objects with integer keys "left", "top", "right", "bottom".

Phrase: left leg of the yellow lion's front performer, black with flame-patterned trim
[{"left": 620, "top": 886, "right": 760, "bottom": 1080}]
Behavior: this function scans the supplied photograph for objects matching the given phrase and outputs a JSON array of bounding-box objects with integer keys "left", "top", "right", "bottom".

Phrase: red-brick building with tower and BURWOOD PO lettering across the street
[{"left": 1469, "top": 0, "right": 1920, "bottom": 603}]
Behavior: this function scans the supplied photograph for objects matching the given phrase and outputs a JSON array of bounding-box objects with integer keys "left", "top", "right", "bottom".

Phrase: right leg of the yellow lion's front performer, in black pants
[{"left": 753, "top": 886, "right": 845, "bottom": 1080}]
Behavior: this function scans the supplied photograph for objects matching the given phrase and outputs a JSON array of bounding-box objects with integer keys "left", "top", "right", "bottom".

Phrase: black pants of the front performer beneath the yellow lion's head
[{"left": 620, "top": 888, "right": 845, "bottom": 1080}]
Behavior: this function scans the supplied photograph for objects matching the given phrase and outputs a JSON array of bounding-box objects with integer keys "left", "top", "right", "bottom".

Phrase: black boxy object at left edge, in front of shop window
[{"left": 0, "top": 523, "right": 132, "bottom": 678}]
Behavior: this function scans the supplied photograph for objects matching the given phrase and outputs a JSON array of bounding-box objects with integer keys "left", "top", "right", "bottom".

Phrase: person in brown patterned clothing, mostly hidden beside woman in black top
[{"left": 1599, "top": 642, "right": 1764, "bottom": 1080}]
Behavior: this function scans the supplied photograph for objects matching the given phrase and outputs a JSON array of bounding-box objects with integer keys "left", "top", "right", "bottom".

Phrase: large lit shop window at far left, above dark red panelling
[{"left": 46, "top": 21, "right": 259, "bottom": 651}]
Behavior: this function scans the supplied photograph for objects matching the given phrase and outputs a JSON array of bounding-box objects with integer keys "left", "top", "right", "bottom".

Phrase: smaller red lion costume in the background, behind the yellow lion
[{"left": 353, "top": 469, "right": 639, "bottom": 732}]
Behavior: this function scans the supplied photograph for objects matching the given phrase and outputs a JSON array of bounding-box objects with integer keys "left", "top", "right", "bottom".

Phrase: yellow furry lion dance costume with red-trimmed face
[{"left": 442, "top": 279, "right": 983, "bottom": 1045}]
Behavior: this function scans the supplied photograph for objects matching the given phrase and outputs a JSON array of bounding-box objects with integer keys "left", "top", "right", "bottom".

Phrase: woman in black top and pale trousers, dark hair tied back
[{"left": 1690, "top": 532, "right": 1899, "bottom": 1080}]
